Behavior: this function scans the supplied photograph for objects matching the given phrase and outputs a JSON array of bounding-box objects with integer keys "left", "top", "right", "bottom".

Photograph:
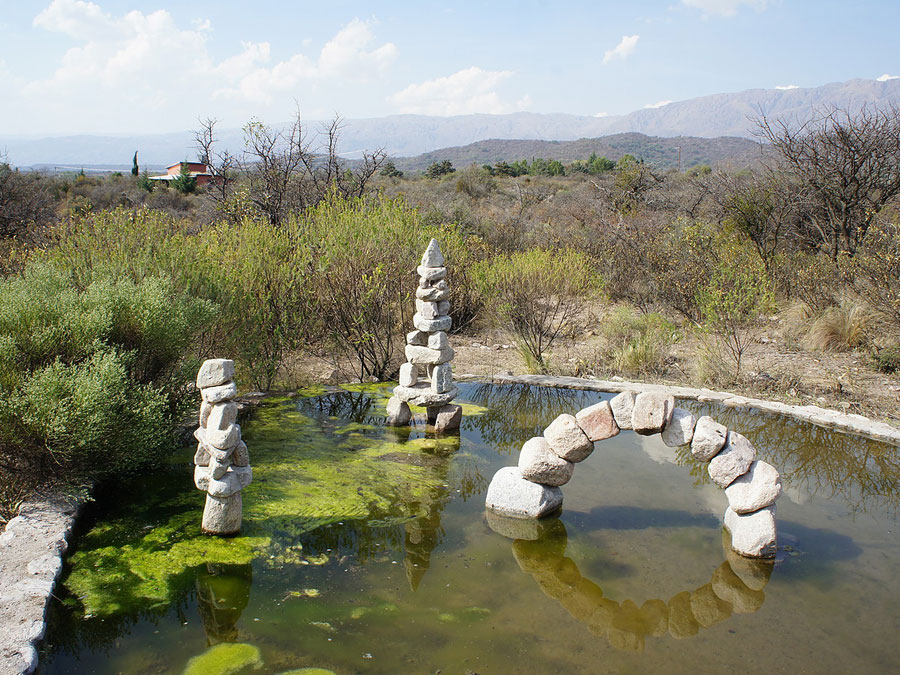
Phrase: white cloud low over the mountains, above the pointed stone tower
[{"left": 388, "top": 66, "right": 531, "bottom": 115}]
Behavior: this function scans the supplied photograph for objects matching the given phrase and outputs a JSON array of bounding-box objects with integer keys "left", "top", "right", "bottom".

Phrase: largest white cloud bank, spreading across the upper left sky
[{"left": 22, "top": 0, "right": 397, "bottom": 128}]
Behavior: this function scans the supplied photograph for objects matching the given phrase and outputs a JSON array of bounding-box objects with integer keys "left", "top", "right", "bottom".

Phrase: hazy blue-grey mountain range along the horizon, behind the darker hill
[{"left": 0, "top": 79, "right": 900, "bottom": 168}]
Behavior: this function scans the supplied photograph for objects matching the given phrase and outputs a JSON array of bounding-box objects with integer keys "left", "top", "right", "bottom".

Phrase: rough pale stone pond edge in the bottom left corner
[{"left": 0, "top": 492, "right": 87, "bottom": 675}]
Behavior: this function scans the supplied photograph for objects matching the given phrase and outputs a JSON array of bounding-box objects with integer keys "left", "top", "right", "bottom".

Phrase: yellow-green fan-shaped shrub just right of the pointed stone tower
[{"left": 477, "top": 248, "right": 599, "bottom": 371}]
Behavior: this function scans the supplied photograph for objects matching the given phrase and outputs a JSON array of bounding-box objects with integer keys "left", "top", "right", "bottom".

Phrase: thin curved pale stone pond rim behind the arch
[{"left": 456, "top": 373, "right": 900, "bottom": 447}]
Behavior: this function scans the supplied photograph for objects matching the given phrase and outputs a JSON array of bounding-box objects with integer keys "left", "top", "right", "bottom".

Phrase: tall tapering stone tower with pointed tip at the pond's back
[{"left": 387, "top": 239, "right": 462, "bottom": 432}]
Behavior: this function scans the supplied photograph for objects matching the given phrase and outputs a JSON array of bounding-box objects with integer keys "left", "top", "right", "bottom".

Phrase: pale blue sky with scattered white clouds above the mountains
[{"left": 0, "top": 0, "right": 900, "bottom": 136}]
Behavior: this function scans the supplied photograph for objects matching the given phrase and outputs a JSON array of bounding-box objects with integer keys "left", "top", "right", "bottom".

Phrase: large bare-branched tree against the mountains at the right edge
[{"left": 756, "top": 104, "right": 900, "bottom": 260}]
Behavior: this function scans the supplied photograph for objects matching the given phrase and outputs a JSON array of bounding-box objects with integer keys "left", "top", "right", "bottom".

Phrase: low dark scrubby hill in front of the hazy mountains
[{"left": 394, "top": 133, "right": 760, "bottom": 172}]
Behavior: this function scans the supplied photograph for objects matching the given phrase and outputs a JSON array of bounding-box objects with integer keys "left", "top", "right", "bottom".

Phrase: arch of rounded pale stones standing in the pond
[{"left": 486, "top": 391, "right": 781, "bottom": 558}]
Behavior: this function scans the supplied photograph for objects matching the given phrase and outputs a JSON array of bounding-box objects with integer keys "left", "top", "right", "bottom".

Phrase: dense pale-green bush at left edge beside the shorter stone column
[{"left": 0, "top": 262, "right": 213, "bottom": 492}]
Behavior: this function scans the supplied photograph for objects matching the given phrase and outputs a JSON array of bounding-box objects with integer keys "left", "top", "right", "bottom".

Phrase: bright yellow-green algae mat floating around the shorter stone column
[{"left": 65, "top": 385, "right": 468, "bottom": 616}]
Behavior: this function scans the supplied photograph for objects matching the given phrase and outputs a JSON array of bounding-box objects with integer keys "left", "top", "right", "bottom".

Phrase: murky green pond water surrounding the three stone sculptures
[{"left": 40, "top": 384, "right": 900, "bottom": 675}]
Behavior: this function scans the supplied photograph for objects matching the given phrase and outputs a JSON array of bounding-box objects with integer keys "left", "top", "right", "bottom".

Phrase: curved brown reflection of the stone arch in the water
[{"left": 485, "top": 511, "right": 774, "bottom": 651}]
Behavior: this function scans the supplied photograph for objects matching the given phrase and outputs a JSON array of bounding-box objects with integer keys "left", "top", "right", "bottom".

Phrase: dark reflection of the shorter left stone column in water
[{"left": 196, "top": 564, "right": 253, "bottom": 646}]
